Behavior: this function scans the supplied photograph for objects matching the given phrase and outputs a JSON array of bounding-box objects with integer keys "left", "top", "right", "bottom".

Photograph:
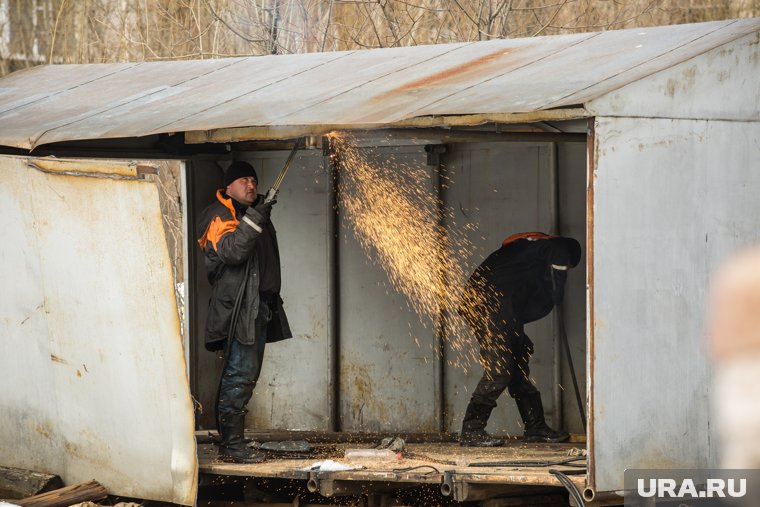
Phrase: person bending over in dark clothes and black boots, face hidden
[{"left": 460, "top": 232, "right": 581, "bottom": 447}]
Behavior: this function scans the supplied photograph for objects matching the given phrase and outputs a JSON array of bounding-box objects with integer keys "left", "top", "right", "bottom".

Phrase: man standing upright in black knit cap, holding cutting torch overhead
[{"left": 198, "top": 161, "right": 292, "bottom": 463}]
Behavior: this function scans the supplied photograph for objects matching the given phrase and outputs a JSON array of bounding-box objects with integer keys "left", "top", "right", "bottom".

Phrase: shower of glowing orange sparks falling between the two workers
[{"left": 329, "top": 132, "right": 510, "bottom": 376}]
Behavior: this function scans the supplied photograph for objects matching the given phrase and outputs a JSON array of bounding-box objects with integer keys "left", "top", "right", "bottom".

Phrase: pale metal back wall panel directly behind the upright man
[{"left": 246, "top": 150, "right": 331, "bottom": 430}]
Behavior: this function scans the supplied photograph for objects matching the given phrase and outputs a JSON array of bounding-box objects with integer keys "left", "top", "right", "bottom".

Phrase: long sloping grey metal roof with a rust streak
[{"left": 0, "top": 18, "right": 760, "bottom": 148}]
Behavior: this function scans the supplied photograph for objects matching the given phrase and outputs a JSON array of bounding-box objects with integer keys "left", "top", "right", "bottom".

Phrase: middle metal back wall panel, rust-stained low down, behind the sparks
[{"left": 339, "top": 147, "right": 436, "bottom": 431}]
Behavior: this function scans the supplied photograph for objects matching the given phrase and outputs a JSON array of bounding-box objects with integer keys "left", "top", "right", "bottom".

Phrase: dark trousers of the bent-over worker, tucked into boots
[{"left": 462, "top": 316, "right": 538, "bottom": 431}]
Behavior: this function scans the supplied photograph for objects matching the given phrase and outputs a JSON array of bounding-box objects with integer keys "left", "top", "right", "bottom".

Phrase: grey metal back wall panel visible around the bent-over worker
[{"left": 445, "top": 143, "right": 554, "bottom": 435}]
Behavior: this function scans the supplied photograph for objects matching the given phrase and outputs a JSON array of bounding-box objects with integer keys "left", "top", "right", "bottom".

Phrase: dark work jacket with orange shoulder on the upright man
[{"left": 198, "top": 190, "right": 293, "bottom": 350}]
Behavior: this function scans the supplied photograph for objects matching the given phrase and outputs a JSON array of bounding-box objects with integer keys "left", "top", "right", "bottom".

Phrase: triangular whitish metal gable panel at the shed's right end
[{"left": 587, "top": 30, "right": 760, "bottom": 121}]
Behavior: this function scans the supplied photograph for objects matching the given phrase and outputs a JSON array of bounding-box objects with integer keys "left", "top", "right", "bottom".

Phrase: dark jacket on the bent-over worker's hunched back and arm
[{"left": 467, "top": 233, "right": 580, "bottom": 324}]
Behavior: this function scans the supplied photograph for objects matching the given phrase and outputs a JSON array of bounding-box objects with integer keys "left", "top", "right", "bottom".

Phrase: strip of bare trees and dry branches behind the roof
[{"left": 0, "top": 0, "right": 760, "bottom": 74}]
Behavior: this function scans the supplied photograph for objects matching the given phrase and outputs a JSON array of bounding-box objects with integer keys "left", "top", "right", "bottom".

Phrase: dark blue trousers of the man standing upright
[{"left": 219, "top": 298, "right": 272, "bottom": 424}]
